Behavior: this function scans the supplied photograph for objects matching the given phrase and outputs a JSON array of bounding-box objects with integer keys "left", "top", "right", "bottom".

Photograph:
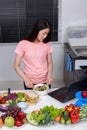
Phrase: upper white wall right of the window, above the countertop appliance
[{"left": 61, "top": 0, "right": 87, "bottom": 41}]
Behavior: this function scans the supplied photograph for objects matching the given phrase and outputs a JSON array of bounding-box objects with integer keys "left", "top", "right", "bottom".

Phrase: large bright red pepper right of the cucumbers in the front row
[{"left": 70, "top": 109, "right": 80, "bottom": 123}]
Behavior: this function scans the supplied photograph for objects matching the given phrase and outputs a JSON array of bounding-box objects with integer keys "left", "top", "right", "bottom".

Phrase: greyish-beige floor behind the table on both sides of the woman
[{"left": 0, "top": 81, "right": 65, "bottom": 91}]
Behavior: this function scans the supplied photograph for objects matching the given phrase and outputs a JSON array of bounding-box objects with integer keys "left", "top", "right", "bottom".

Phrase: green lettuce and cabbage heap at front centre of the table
[{"left": 26, "top": 106, "right": 64, "bottom": 125}]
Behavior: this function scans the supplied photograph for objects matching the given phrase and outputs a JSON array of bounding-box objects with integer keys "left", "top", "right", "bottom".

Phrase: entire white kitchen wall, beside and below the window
[{"left": 0, "top": 0, "right": 87, "bottom": 86}]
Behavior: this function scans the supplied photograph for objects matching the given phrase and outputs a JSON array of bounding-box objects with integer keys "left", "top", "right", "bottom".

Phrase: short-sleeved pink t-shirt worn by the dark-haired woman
[{"left": 15, "top": 40, "right": 52, "bottom": 84}]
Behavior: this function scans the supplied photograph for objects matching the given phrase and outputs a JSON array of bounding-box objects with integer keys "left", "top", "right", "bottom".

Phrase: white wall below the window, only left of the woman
[{"left": 0, "top": 45, "right": 19, "bottom": 81}]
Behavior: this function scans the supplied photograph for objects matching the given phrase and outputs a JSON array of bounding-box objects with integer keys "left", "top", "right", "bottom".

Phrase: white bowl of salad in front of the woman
[{"left": 33, "top": 84, "right": 49, "bottom": 95}]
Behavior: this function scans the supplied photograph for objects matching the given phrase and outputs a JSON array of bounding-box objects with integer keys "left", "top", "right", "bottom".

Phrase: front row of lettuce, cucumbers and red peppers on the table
[{"left": 26, "top": 104, "right": 80, "bottom": 125}]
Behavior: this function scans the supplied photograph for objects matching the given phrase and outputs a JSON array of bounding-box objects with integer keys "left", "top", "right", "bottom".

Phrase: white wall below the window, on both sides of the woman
[{"left": 0, "top": 44, "right": 63, "bottom": 81}]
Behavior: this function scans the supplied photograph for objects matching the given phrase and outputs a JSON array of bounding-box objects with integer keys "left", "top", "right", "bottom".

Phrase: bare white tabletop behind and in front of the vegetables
[{"left": 0, "top": 89, "right": 87, "bottom": 130}]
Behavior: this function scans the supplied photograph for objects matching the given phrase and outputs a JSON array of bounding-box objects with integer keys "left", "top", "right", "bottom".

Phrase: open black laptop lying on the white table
[{"left": 48, "top": 79, "right": 87, "bottom": 103}]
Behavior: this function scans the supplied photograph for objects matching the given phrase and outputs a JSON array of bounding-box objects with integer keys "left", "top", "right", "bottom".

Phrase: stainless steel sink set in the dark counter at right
[{"left": 71, "top": 46, "right": 87, "bottom": 57}]
